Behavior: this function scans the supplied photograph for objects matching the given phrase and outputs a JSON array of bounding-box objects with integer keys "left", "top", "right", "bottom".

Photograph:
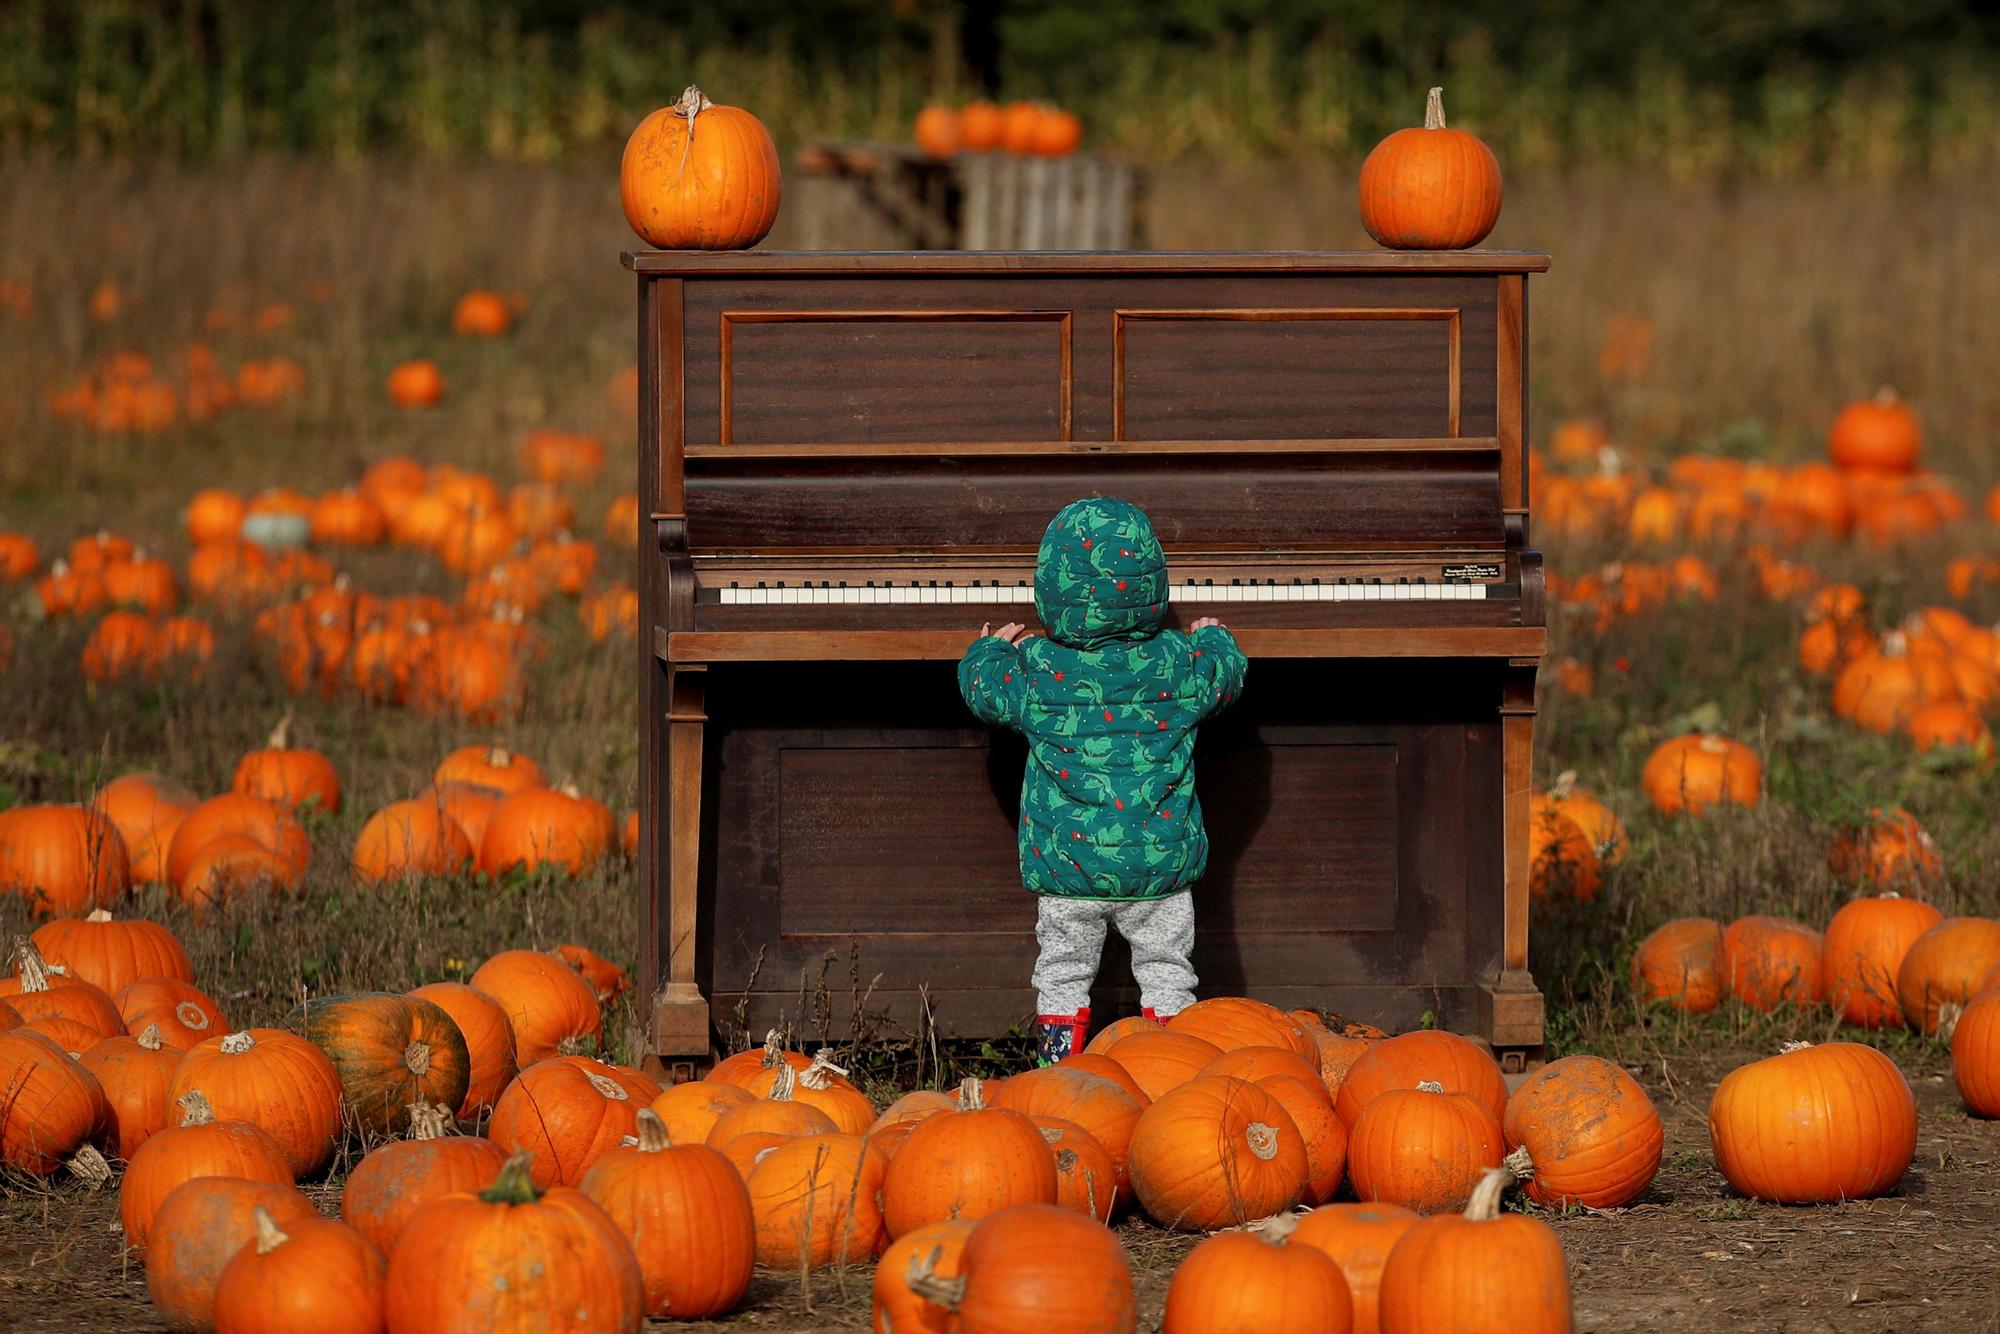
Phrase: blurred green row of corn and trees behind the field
[{"left": 0, "top": 0, "right": 2000, "bottom": 176}]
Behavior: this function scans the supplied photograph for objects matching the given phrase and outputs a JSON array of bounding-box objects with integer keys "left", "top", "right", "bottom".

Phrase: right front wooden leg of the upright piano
[{"left": 1478, "top": 658, "right": 1542, "bottom": 1074}]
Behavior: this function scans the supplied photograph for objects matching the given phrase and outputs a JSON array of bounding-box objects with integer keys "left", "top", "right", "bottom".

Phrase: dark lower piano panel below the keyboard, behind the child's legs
[{"left": 700, "top": 662, "right": 1500, "bottom": 1034}]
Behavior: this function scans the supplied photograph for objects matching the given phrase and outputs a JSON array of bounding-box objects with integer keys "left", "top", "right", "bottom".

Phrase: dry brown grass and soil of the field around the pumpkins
[{"left": 0, "top": 160, "right": 2000, "bottom": 1330}]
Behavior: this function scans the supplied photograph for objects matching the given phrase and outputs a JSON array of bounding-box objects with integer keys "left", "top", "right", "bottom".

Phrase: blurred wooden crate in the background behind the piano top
[{"left": 792, "top": 144, "right": 1144, "bottom": 250}]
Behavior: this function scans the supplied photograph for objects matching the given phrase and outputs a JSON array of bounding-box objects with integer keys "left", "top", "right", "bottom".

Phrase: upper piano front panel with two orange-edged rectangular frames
[{"left": 682, "top": 272, "right": 1502, "bottom": 452}]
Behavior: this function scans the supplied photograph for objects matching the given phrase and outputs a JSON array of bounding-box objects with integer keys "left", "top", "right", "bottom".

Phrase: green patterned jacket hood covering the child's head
[{"left": 1034, "top": 496, "right": 1166, "bottom": 648}]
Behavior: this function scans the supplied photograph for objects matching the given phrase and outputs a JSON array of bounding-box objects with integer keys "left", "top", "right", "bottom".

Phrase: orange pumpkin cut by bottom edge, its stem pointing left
[{"left": 906, "top": 1204, "right": 1138, "bottom": 1334}]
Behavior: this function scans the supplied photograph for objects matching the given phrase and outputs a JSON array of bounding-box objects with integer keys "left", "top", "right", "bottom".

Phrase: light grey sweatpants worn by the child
[{"left": 1034, "top": 892, "right": 1194, "bottom": 1018}]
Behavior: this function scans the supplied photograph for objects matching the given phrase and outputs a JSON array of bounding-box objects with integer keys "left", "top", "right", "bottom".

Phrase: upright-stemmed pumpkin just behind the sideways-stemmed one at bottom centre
[{"left": 882, "top": 1080, "right": 1056, "bottom": 1238}]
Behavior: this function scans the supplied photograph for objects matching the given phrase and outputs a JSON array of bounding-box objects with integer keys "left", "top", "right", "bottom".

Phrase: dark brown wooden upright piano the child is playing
[{"left": 626, "top": 250, "right": 1548, "bottom": 1074}]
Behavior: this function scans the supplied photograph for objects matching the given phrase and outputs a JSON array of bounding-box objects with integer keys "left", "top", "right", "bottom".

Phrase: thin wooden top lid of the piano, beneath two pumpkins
[{"left": 622, "top": 250, "right": 1548, "bottom": 276}]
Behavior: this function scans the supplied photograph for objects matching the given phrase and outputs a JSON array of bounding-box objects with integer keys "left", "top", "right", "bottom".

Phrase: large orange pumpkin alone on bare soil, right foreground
[{"left": 1708, "top": 1042, "right": 1916, "bottom": 1204}]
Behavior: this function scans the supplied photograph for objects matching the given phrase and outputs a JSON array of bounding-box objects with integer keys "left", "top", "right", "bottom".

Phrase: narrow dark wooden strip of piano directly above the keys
[{"left": 688, "top": 446, "right": 1504, "bottom": 554}]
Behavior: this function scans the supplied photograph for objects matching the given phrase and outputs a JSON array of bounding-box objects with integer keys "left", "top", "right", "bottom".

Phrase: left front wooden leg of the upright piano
[{"left": 648, "top": 664, "right": 712, "bottom": 1082}]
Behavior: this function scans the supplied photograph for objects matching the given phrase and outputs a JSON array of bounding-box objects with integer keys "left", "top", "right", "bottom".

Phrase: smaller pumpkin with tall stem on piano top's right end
[{"left": 1360, "top": 88, "right": 1500, "bottom": 250}]
